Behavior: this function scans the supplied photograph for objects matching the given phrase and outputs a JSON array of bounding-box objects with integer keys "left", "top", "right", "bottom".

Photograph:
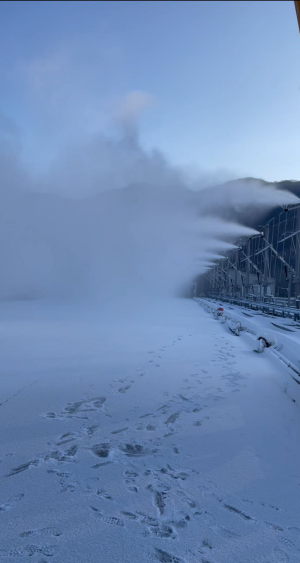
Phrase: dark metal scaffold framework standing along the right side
[{"left": 206, "top": 204, "right": 300, "bottom": 308}]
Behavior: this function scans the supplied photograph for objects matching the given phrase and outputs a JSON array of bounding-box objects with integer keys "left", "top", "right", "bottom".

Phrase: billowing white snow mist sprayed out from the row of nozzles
[{"left": 0, "top": 73, "right": 297, "bottom": 306}]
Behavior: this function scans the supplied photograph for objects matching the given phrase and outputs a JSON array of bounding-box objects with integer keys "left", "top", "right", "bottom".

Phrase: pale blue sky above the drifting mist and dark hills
[{"left": 0, "top": 1, "right": 300, "bottom": 180}]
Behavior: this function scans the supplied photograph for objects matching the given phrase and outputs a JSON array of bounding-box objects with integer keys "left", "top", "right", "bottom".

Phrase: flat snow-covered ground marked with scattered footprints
[{"left": 0, "top": 300, "right": 300, "bottom": 563}]
